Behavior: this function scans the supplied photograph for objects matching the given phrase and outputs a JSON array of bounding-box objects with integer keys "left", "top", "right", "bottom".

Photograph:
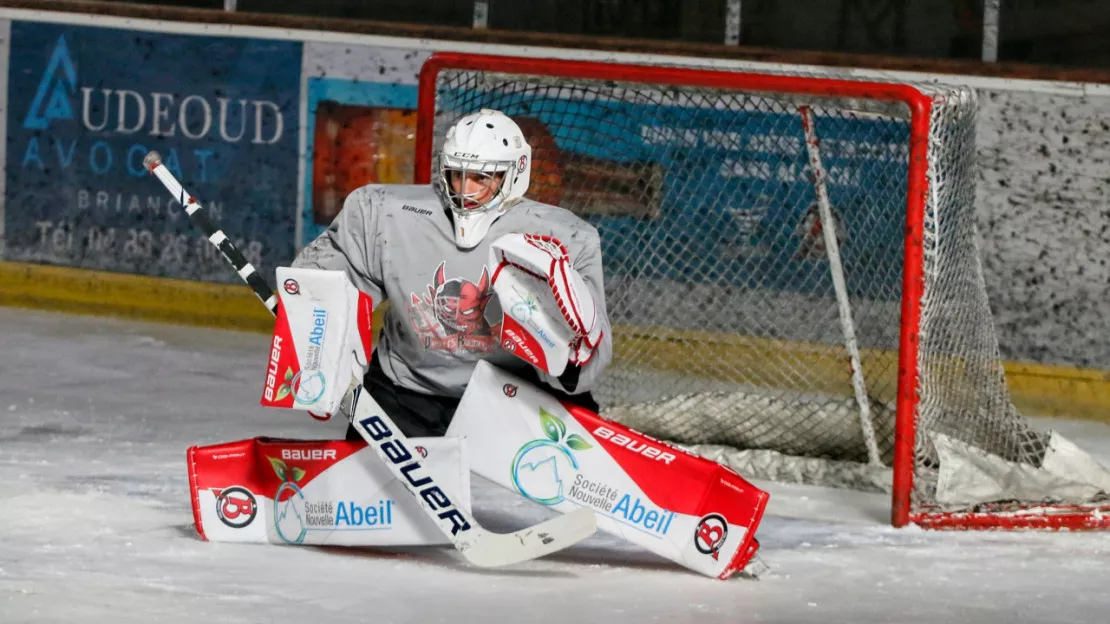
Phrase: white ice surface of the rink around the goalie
[{"left": 0, "top": 309, "right": 1110, "bottom": 624}]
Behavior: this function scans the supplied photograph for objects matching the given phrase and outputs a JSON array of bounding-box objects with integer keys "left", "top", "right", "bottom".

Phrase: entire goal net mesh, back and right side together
[{"left": 424, "top": 65, "right": 1043, "bottom": 506}]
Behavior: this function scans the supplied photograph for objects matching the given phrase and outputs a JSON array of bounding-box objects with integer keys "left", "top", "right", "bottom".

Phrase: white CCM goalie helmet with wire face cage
[{"left": 438, "top": 109, "right": 532, "bottom": 249}]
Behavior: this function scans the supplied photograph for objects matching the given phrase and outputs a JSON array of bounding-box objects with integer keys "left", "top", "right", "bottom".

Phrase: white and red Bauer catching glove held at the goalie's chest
[{"left": 490, "top": 234, "right": 602, "bottom": 376}]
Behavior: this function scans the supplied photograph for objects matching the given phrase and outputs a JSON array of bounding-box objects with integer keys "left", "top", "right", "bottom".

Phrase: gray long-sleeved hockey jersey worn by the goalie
[{"left": 293, "top": 184, "right": 613, "bottom": 396}]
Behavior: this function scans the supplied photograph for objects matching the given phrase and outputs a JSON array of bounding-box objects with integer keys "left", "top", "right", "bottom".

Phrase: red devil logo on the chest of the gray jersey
[{"left": 408, "top": 262, "right": 493, "bottom": 353}]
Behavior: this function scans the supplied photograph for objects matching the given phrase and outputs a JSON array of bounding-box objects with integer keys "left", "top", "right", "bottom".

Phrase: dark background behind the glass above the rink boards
[{"left": 110, "top": 0, "right": 1110, "bottom": 69}]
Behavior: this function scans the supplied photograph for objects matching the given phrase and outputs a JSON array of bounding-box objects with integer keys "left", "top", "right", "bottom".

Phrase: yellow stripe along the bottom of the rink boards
[{"left": 0, "top": 262, "right": 1110, "bottom": 422}]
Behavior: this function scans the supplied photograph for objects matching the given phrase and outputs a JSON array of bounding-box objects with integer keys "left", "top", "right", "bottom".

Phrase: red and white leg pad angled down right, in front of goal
[{"left": 447, "top": 362, "right": 768, "bottom": 578}]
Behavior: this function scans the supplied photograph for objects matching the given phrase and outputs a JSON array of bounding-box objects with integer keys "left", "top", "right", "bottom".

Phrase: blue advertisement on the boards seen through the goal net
[{"left": 437, "top": 89, "right": 909, "bottom": 298}]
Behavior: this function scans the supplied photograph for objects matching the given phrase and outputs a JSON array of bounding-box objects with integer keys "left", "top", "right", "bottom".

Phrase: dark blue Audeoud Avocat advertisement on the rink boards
[{"left": 4, "top": 21, "right": 301, "bottom": 281}]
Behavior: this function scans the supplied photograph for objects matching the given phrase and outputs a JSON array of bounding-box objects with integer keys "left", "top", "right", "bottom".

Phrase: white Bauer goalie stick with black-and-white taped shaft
[{"left": 143, "top": 151, "right": 597, "bottom": 567}]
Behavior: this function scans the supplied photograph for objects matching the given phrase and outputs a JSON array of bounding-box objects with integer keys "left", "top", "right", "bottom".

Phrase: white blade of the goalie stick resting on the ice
[{"left": 460, "top": 507, "right": 597, "bottom": 567}]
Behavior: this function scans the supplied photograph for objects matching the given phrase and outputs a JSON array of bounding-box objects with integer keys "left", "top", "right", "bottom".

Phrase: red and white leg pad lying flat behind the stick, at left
[{"left": 186, "top": 437, "right": 471, "bottom": 546}]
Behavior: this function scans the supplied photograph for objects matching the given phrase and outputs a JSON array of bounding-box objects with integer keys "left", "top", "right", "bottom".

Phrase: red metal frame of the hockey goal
[{"left": 413, "top": 52, "right": 1110, "bottom": 530}]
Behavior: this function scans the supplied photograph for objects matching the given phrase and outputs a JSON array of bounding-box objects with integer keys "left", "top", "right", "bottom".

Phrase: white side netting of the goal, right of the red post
[{"left": 912, "top": 90, "right": 1047, "bottom": 509}]
